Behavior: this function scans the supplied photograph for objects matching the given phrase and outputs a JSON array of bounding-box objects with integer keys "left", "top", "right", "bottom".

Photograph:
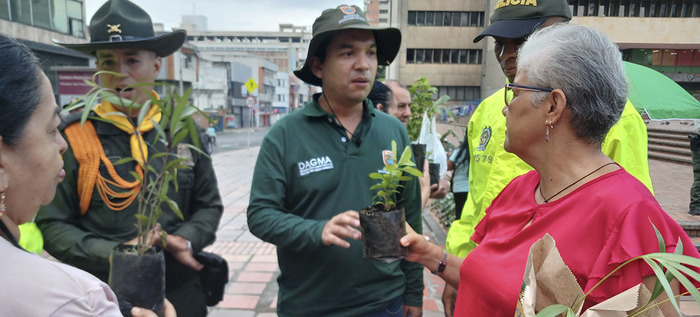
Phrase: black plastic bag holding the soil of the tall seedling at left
[{"left": 109, "top": 244, "right": 165, "bottom": 316}]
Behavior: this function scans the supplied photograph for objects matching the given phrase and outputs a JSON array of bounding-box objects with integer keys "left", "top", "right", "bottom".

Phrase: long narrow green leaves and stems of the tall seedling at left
[{"left": 64, "top": 71, "right": 206, "bottom": 256}]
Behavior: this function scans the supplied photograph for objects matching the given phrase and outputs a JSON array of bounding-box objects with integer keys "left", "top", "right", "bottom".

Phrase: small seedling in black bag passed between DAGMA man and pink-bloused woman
[{"left": 360, "top": 140, "right": 423, "bottom": 263}]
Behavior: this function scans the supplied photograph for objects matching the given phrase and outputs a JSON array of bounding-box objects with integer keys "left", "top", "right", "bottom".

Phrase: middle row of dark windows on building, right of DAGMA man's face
[{"left": 406, "top": 48, "right": 482, "bottom": 65}]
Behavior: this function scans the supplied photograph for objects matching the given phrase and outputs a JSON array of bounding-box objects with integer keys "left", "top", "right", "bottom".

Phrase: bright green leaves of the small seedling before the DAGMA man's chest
[{"left": 369, "top": 140, "right": 423, "bottom": 210}]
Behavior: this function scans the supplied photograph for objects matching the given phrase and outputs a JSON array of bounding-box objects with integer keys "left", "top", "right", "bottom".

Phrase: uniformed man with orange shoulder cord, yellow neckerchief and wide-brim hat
[{"left": 36, "top": 0, "right": 223, "bottom": 317}]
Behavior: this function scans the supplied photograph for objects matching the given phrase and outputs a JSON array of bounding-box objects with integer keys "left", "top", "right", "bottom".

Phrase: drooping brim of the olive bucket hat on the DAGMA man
[{"left": 294, "top": 24, "right": 401, "bottom": 86}]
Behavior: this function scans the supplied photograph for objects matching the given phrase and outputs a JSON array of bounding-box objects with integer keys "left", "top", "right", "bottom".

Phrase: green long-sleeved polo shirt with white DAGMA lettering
[{"left": 248, "top": 95, "right": 423, "bottom": 316}]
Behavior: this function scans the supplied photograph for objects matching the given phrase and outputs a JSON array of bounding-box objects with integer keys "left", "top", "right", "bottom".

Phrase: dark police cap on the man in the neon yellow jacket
[{"left": 474, "top": 0, "right": 571, "bottom": 43}]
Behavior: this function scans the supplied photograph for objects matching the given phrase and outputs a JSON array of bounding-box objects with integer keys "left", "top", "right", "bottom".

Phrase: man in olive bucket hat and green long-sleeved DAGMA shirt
[{"left": 248, "top": 6, "right": 423, "bottom": 317}]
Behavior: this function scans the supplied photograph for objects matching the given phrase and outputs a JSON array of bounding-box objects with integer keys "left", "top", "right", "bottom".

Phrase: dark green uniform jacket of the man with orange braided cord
[{"left": 36, "top": 114, "right": 223, "bottom": 286}]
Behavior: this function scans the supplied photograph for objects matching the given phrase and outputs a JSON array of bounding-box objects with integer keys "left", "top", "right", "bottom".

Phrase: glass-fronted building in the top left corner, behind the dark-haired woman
[{"left": 0, "top": 0, "right": 93, "bottom": 100}]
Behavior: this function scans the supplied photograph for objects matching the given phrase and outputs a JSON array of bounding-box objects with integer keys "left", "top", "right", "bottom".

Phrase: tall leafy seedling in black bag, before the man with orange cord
[{"left": 66, "top": 72, "right": 206, "bottom": 316}]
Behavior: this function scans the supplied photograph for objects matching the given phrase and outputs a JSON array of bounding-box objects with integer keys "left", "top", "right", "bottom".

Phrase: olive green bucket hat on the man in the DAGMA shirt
[{"left": 294, "top": 5, "right": 401, "bottom": 86}]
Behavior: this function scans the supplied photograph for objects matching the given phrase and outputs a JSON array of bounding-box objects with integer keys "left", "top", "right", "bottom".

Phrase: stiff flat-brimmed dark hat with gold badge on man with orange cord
[{"left": 55, "top": 0, "right": 187, "bottom": 57}]
